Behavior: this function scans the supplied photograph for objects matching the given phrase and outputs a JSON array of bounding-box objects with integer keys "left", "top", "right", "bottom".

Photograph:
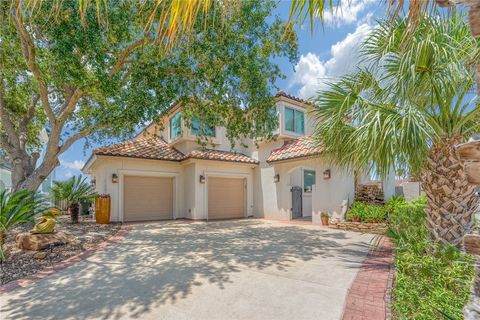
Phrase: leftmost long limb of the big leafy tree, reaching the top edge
[{"left": 13, "top": 2, "right": 56, "bottom": 126}]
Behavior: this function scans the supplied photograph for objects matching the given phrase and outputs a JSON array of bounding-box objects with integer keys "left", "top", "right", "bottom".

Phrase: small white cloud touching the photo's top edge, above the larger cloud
[{"left": 324, "top": 0, "right": 378, "bottom": 26}]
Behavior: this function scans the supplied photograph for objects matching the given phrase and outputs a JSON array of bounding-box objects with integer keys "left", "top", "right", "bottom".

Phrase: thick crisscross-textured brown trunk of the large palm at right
[{"left": 422, "top": 137, "right": 478, "bottom": 245}]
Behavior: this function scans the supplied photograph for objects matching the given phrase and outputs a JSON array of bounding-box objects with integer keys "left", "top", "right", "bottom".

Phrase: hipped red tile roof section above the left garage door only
[{"left": 93, "top": 138, "right": 184, "bottom": 161}]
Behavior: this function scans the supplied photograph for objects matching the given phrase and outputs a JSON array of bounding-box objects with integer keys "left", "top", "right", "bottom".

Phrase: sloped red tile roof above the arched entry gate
[{"left": 267, "top": 136, "right": 322, "bottom": 162}]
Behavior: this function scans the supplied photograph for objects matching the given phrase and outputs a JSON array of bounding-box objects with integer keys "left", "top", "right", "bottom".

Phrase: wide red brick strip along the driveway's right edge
[{"left": 343, "top": 238, "right": 393, "bottom": 320}]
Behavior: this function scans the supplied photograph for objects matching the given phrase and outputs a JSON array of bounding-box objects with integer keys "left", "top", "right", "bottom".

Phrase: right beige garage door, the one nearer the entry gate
[{"left": 207, "top": 178, "right": 245, "bottom": 219}]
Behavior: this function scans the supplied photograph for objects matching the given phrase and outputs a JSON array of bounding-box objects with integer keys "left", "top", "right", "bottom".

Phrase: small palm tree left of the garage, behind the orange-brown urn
[{"left": 51, "top": 176, "right": 97, "bottom": 223}]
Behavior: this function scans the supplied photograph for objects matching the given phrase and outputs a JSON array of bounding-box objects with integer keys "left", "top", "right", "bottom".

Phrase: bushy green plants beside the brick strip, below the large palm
[{"left": 387, "top": 197, "right": 475, "bottom": 320}]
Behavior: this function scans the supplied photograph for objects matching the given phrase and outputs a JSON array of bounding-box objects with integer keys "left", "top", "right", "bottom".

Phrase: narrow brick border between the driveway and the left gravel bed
[{"left": 0, "top": 224, "right": 133, "bottom": 294}]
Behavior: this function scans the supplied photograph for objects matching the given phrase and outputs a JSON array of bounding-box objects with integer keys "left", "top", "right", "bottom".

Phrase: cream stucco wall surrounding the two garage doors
[{"left": 90, "top": 157, "right": 253, "bottom": 221}]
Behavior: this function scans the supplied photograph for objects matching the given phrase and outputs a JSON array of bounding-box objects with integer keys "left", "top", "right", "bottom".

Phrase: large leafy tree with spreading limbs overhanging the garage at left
[{"left": 0, "top": 0, "right": 297, "bottom": 190}]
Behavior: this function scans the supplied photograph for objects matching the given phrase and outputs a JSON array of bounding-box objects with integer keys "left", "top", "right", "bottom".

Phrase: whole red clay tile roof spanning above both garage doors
[{"left": 93, "top": 138, "right": 258, "bottom": 164}]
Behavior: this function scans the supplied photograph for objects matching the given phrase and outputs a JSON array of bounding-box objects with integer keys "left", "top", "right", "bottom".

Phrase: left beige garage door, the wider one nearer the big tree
[{"left": 123, "top": 176, "right": 173, "bottom": 221}]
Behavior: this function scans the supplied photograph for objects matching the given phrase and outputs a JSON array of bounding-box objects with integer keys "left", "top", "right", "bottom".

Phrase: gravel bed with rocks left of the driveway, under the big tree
[{"left": 0, "top": 215, "right": 120, "bottom": 284}]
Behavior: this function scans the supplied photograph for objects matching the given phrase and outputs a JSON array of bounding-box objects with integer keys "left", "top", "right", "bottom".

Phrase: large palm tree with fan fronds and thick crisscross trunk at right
[{"left": 313, "top": 13, "right": 480, "bottom": 244}]
